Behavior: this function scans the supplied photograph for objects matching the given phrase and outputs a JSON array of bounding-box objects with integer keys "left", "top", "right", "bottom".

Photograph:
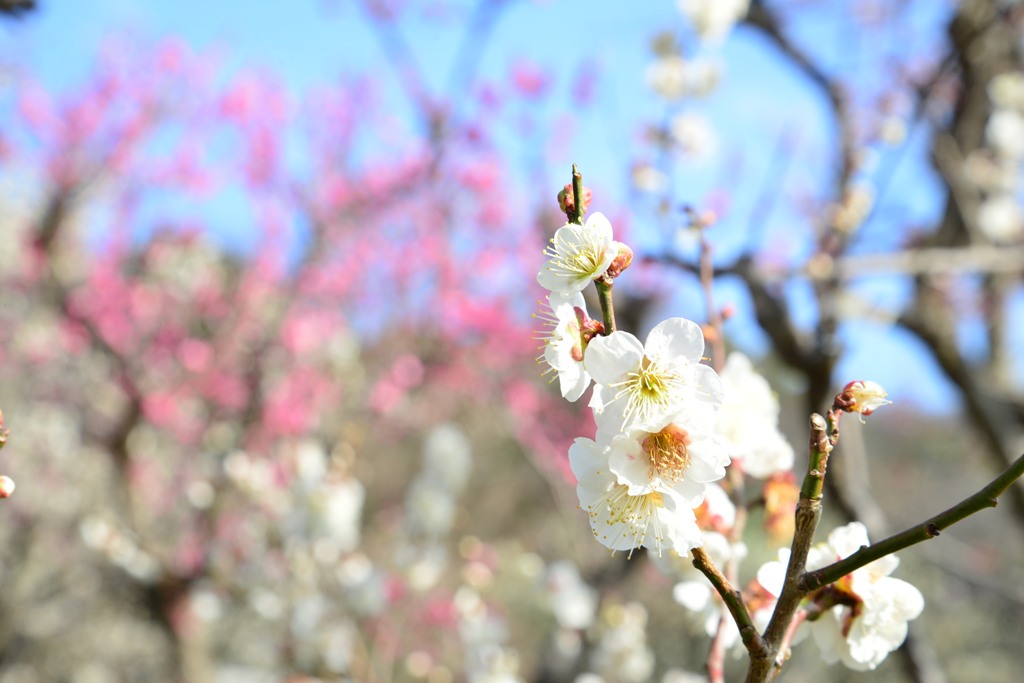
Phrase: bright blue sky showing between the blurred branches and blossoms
[{"left": 0, "top": 0, "right": 991, "bottom": 411}]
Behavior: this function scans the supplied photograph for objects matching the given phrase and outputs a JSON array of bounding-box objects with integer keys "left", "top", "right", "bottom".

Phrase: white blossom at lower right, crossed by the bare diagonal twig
[{"left": 807, "top": 522, "right": 925, "bottom": 671}]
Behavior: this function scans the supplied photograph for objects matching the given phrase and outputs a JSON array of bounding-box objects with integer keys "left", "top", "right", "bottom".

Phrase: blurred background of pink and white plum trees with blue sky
[{"left": 0, "top": 0, "right": 1024, "bottom": 683}]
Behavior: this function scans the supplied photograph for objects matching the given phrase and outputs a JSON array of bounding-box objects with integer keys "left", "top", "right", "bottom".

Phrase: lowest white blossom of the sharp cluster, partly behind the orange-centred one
[{"left": 569, "top": 437, "right": 701, "bottom": 555}]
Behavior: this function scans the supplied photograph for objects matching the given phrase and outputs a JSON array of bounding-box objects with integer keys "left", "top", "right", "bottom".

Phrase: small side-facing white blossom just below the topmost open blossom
[{"left": 540, "top": 292, "right": 590, "bottom": 400}]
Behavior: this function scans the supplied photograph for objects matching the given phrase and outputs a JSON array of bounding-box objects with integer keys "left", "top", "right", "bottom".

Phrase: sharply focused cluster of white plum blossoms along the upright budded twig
[{"left": 538, "top": 187, "right": 728, "bottom": 555}]
